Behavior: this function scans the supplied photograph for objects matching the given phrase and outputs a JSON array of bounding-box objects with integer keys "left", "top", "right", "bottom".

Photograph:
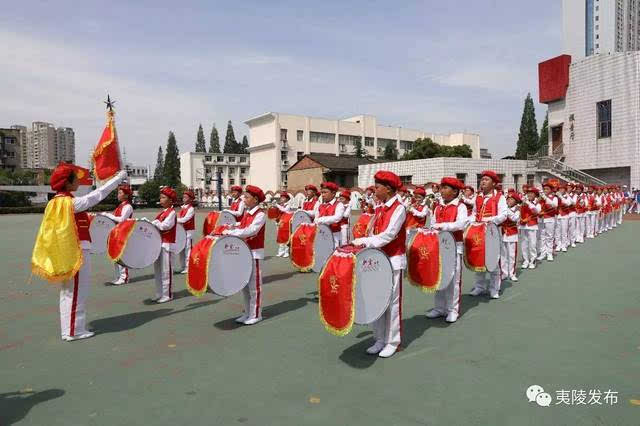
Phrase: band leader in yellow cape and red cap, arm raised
[{"left": 31, "top": 163, "right": 127, "bottom": 342}]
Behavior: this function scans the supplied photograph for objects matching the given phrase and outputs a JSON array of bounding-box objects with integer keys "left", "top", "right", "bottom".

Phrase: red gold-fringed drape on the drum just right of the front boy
[{"left": 407, "top": 231, "right": 442, "bottom": 293}]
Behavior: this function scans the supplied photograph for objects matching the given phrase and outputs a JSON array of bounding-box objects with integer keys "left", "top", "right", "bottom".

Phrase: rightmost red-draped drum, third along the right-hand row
[{"left": 464, "top": 222, "right": 502, "bottom": 272}]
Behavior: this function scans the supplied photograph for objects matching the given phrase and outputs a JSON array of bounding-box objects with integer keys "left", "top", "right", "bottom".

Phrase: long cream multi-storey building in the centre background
[{"left": 245, "top": 112, "right": 480, "bottom": 191}]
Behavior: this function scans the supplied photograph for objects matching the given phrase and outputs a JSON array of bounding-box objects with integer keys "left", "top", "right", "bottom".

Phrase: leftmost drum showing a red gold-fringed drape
[{"left": 107, "top": 219, "right": 162, "bottom": 269}]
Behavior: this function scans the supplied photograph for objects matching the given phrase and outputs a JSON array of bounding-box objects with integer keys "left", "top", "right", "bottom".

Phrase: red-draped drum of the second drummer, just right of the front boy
[{"left": 407, "top": 228, "right": 457, "bottom": 292}]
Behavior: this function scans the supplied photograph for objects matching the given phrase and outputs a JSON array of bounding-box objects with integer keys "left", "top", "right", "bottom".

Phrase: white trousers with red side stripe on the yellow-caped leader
[{"left": 60, "top": 250, "right": 91, "bottom": 337}]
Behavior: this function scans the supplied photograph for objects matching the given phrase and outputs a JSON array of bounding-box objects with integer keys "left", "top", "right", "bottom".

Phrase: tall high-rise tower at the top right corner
[{"left": 562, "top": 0, "right": 640, "bottom": 62}]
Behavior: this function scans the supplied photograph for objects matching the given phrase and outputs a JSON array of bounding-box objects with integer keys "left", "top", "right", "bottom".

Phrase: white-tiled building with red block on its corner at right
[{"left": 540, "top": 52, "right": 640, "bottom": 188}]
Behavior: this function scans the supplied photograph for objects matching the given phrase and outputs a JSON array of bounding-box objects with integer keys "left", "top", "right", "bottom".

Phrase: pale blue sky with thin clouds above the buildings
[{"left": 0, "top": 0, "right": 562, "bottom": 167}]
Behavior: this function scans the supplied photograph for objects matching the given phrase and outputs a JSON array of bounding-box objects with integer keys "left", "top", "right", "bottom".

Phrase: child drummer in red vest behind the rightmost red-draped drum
[{"left": 469, "top": 170, "right": 507, "bottom": 299}]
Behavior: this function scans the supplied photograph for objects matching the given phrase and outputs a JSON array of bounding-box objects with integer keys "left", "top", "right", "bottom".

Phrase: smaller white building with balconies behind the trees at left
[{"left": 180, "top": 152, "right": 251, "bottom": 195}]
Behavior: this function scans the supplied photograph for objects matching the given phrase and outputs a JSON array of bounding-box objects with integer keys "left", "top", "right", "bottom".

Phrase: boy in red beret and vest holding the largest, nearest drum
[{"left": 353, "top": 170, "right": 407, "bottom": 358}]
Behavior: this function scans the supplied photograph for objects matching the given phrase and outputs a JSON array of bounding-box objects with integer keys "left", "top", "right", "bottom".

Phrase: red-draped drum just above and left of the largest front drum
[{"left": 290, "top": 223, "right": 334, "bottom": 272}]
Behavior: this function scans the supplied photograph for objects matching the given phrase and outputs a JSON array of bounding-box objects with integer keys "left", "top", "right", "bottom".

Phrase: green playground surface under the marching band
[{"left": 0, "top": 211, "right": 640, "bottom": 426}]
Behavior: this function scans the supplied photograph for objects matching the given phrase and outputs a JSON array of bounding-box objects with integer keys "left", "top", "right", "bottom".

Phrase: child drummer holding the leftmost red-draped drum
[{"left": 151, "top": 186, "right": 178, "bottom": 303}]
